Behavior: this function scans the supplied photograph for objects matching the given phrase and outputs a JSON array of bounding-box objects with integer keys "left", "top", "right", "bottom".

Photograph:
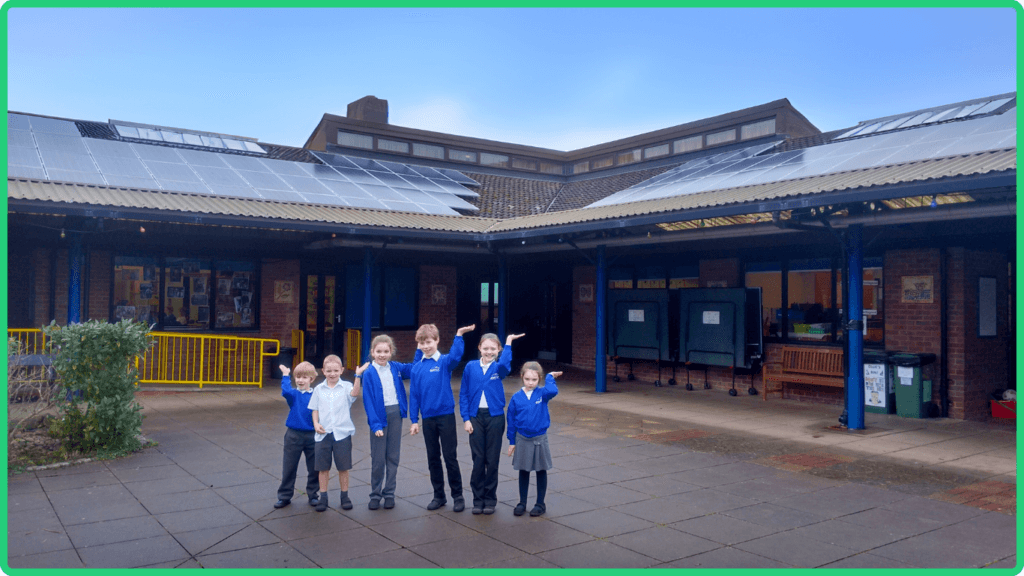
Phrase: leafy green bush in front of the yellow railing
[{"left": 43, "top": 320, "right": 151, "bottom": 452}]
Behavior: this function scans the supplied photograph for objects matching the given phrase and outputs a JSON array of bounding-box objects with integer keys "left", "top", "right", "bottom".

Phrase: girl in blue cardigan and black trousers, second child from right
[{"left": 459, "top": 334, "right": 524, "bottom": 515}]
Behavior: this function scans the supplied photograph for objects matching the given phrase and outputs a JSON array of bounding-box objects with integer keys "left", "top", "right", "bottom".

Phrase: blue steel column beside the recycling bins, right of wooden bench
[{"left": 846, "top": 224, "right": 864, "bottom": 430}]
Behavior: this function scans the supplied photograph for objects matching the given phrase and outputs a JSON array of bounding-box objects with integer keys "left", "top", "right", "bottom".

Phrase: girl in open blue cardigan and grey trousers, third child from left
[{"left": 360, "top": 334, "right": 413, "bottom": 510}]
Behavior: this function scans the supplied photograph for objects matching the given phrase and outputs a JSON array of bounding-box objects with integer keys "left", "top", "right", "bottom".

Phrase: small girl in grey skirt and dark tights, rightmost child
[{"left": 508, "top": 362, "right": 562, "bottom": 516}]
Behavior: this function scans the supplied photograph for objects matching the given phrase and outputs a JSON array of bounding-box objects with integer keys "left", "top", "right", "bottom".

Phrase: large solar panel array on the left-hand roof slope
[{"left": 7, "top": 113, "right": 478, "bottom": 215}]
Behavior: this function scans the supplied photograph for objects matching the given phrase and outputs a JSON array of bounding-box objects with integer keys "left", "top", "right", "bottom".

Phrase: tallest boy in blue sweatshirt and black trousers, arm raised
[{"left": 409, "top": 324, "right": 476, "bottom": 512}]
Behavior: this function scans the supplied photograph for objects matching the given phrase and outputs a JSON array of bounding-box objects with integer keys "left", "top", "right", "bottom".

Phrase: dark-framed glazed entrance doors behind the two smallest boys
[{"left": 300, "top": 272, "right": 343, "bottom": 366}]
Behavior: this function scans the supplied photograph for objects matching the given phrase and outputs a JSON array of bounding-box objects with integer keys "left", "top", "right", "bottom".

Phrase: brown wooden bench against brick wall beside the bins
[{"left": 761, "top": 346, "right": 845, "bottom": 400}]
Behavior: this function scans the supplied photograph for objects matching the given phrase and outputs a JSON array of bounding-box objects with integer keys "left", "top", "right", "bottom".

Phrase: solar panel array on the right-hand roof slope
[{"left": 589, "top": 109, "right": 1017, "bottom": 207}]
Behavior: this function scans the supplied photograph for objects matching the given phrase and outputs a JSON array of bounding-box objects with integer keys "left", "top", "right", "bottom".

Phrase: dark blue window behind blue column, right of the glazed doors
[{"left": 345, "top": 264, "right": 419, "bottom": 328}]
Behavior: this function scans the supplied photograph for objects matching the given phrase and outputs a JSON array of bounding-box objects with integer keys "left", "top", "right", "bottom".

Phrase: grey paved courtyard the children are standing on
[{"left": 7, "top": 373, "right": 1017, "bottom": 568}]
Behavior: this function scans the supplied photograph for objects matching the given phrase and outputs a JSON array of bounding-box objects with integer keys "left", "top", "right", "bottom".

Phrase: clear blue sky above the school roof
[{"left": 7, "top": 7, "right": 1017, "bottom": 150}]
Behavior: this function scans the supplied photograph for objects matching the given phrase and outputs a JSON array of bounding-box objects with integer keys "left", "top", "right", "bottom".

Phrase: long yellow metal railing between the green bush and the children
[{"left": 135, "top": 332, "right": 281, "bottom": 387}]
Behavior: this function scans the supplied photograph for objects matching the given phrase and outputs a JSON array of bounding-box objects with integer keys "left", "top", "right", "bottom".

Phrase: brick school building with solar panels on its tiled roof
[{"left": 7, "top": 93, "right": 1017, "bottom": 419}]
